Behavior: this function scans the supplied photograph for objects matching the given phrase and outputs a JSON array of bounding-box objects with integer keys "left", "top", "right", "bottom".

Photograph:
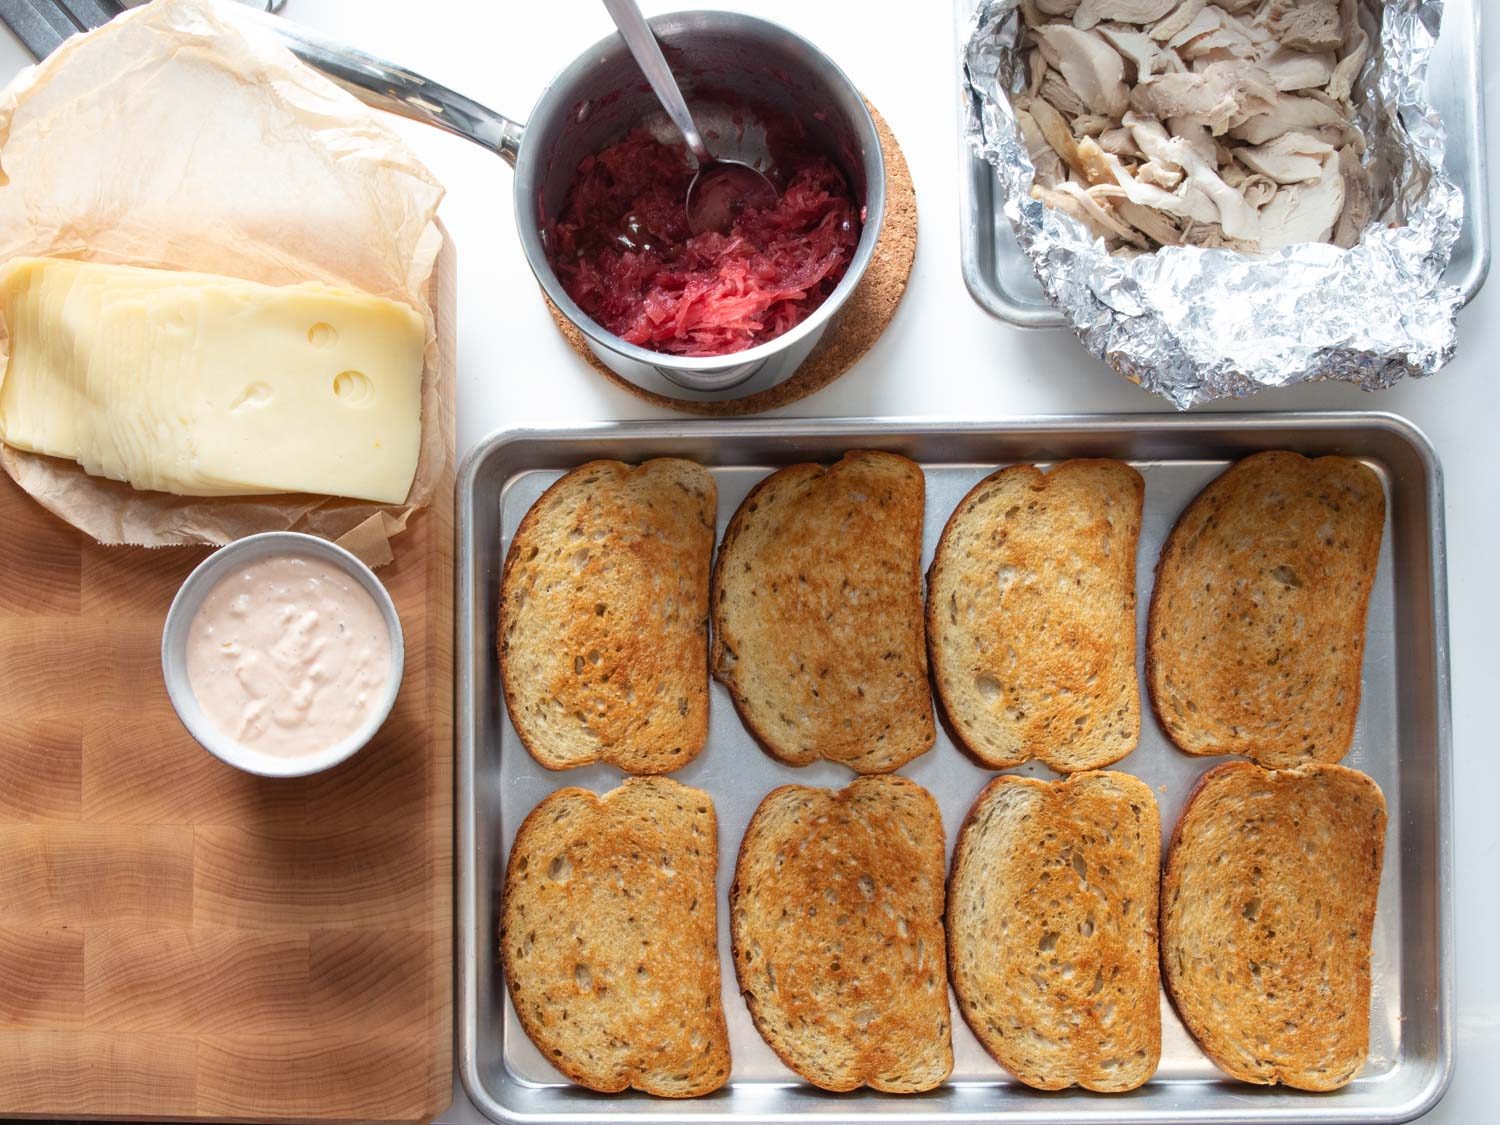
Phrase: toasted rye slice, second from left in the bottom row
[{"left": 729, "top": 777, "right": 953, "bottom": 1094}]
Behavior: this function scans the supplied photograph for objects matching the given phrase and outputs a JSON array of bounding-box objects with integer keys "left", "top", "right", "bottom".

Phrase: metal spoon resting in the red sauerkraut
[{"left": 605, "top": 0, "right": 780, "bottom": 234}]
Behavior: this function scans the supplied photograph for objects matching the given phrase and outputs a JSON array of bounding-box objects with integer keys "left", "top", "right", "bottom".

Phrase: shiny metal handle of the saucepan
[{"left": 243, "top": 11, "right": 525, "bottom": 165}]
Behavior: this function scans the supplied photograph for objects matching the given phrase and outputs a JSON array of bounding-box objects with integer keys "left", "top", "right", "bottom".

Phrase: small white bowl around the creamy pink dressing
[{"left": 162, "top": 531, "right": 407, "bottom": 777}]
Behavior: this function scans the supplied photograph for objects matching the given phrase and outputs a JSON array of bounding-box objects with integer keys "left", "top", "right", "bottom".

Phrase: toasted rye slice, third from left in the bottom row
[{"left": 948, "top": 771, "right": 1161, "bottom": 1092}]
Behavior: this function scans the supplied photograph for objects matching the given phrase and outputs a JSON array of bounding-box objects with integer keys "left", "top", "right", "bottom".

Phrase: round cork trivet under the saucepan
[{"left": 548, "top": 102, "right": 917, "bottom": 417}]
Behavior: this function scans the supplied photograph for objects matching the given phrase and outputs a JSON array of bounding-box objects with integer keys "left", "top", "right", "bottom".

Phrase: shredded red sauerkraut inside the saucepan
[{"left": 551, "top": 129, "right": 860, "bottom": 356}]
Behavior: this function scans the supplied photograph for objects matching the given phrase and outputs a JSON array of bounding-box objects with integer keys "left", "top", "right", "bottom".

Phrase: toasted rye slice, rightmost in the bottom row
[{"left": 1161, "top": 762, "right": 1386, "bottom": 1091}]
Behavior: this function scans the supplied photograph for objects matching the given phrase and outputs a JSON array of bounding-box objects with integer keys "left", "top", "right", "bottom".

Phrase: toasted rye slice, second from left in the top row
[{"left": 713, "top": 452, "right": 936, "bottom": 774}]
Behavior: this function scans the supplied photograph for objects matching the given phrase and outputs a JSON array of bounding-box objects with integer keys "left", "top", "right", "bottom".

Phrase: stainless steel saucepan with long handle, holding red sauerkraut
[{"left": 261, "top": 12, "right": 885, "bottom": 399}]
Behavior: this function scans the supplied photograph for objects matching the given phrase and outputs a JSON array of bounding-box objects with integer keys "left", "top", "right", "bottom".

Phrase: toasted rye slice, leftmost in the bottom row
[{"left": 500, "top": 777, "right": 729, "bottom": 1098}]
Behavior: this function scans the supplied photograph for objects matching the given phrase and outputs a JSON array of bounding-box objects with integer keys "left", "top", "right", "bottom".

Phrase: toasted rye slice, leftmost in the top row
[{"left": 500, "top": 458, "right": 719, "bottom": 774}]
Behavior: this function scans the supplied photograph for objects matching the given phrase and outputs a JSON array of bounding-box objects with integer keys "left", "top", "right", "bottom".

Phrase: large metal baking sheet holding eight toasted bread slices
[{"left": 456, "top": 414, "right": 1452, "bottom": 1122}]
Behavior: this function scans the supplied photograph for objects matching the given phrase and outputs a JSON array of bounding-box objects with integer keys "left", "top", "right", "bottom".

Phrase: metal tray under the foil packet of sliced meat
[{"left": 954, "top": 0, "right": 1490, "bottom": 329}]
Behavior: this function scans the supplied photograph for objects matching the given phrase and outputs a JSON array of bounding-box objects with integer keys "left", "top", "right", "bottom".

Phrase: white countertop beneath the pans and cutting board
[{"left": 0, "top": 0, "right": 1500, "bottom": 1122}]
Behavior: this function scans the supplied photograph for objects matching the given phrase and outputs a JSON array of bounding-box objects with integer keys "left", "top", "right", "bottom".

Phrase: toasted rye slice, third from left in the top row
[{"left": 927, "top": 461, "right": 1146, "bottom": 773}]
